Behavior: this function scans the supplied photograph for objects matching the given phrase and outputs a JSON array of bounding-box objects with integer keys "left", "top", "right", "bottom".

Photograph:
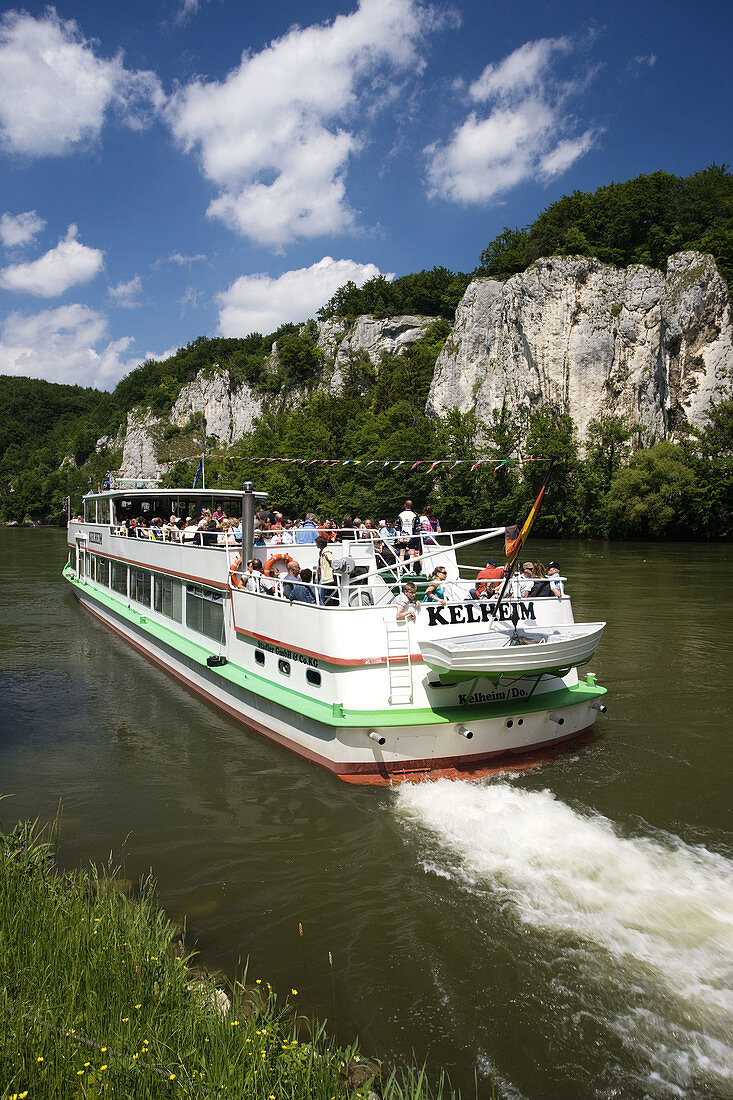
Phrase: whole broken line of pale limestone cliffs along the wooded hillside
[{"left": 112, "top": 252, "right": 733, "bottom": 476}]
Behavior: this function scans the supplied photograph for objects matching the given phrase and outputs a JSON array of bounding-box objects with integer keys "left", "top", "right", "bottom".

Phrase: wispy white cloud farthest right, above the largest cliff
[{"left": 425, "top": 37, "right": 598, "bottom": 204}]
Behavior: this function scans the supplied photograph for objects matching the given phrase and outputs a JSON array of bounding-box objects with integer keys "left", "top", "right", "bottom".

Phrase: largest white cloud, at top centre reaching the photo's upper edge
[{"left": 168, "top": 0, "right": 434, "bottom": 248}]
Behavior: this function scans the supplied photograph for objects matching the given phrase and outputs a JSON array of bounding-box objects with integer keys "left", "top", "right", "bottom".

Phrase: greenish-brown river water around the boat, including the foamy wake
[{"left": 0, "top": 530, "right": 733, "bottom": 1100}]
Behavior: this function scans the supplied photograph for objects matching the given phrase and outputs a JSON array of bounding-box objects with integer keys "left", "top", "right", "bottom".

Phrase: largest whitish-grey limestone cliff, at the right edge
[{"left": 427, "top": 252, "right": 733, "bottom": 441}]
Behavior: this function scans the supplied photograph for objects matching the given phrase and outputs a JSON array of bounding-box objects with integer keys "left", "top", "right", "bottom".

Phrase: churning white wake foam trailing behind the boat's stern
[{"left": 395, "top": 780, "right": 733, "bottom": 1096}]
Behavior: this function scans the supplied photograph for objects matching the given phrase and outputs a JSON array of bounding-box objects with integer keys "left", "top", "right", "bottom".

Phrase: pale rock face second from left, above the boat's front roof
[{"left": 171, "top": 371, "right": 263, "bottom": 446}]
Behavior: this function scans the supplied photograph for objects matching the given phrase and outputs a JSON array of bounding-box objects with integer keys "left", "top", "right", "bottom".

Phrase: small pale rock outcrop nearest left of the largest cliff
[{"left": 318, "top": 314, "right": 436, "bottom": 394}]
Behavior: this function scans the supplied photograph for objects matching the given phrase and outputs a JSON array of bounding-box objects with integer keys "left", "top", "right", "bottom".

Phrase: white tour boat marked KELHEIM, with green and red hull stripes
[{"left": 64, "top": 483, "right": 605, "bottom": 783}]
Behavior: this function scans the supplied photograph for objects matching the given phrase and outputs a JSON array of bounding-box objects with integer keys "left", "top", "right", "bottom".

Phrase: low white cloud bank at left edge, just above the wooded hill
[{"left": 0, "top": 304, "right": 139, "bottom": 389}]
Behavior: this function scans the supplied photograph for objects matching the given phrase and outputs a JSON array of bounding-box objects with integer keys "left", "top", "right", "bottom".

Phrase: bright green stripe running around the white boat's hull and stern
[{"left": 64, "top": 567, "right": 605, "bottom": 728}]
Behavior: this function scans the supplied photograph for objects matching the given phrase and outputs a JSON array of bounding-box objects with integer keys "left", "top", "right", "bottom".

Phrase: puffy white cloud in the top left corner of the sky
[{"left": 0, "top": 8, "right": 164, "bottom": 156}]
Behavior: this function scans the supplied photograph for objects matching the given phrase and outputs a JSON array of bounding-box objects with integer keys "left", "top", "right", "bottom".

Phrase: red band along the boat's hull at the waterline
[{"left": 75, "top": 590, "right": 594, "bottom": 787}]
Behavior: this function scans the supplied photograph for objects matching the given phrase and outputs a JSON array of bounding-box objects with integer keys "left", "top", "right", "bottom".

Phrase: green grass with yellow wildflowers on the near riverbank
[{"left": 0, "top": 824, "right": 450, "bottom": 1100}]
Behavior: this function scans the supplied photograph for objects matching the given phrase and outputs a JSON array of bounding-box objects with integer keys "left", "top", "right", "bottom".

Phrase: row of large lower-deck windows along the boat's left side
[{"left": 85, "top": 551, "right": 225, "bottom": 641}]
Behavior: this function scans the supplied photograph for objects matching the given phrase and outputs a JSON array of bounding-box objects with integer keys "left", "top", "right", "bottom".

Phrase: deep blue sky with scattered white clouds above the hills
[{"left": 0, "top": 0, "right": 733, "bottom": 388}]
